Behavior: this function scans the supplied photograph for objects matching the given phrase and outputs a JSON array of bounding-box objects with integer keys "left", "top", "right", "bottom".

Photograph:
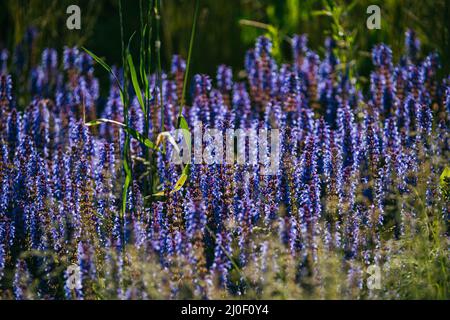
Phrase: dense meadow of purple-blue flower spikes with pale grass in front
[{"left": 0, "top": 25, "right": 450, "bottom": 299}]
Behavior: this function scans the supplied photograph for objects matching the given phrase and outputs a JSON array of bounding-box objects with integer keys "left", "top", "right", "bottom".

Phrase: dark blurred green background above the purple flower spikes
[{"left": 0, "top": 0, "right": 450, "bottom": 82}]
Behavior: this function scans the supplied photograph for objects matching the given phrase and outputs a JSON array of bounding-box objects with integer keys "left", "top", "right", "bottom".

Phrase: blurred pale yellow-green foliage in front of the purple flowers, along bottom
[{"left": 7, "top": 189, "right": 450, "bottom": 300}]
